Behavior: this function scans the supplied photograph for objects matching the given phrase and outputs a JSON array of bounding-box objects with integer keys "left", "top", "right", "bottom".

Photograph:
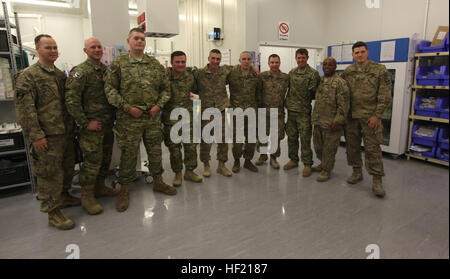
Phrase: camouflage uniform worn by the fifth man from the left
[{"left": 194, "top": 64, "right": 232, "bottom": 163}]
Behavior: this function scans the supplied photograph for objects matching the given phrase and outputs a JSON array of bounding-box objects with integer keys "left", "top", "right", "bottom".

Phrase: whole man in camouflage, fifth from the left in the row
[{"left": 194, "top": 49, "right": 232, "bottom": 177}]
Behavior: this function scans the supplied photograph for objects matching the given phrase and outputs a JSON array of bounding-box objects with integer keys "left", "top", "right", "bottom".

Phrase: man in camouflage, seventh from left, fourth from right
[{"left": 256, "top": 54, "right": 289, "bottom": 169}]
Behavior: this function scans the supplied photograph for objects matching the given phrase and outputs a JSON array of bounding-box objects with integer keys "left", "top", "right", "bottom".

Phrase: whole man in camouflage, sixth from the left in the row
[{"left": 228, "top": 51, "right": 259, "bottom": 173}]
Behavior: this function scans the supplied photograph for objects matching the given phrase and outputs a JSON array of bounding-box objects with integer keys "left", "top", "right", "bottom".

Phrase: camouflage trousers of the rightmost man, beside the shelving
[{"left": 345, "top": 119, "right": 384, "bottom": 176}]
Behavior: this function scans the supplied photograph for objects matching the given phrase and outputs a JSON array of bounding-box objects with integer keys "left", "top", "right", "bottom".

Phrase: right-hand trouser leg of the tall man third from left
[{"left": 143, "top": 114, "right": 164, "bottom": 177}]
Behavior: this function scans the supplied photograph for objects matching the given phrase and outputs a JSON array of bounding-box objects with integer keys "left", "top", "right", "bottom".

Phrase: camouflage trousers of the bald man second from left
[{"left": 80, "top": 127, "right": 114, "bottom": 186}]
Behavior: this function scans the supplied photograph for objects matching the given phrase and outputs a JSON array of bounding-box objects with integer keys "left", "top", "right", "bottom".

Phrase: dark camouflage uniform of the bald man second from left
[{"left": 66, "top": 59, "right": 115, "bottom": 189}]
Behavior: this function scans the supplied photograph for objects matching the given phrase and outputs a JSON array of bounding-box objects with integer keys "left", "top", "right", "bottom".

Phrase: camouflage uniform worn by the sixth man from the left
[{"left": 228, "top": 65, "right": 259, "bottom": 161}]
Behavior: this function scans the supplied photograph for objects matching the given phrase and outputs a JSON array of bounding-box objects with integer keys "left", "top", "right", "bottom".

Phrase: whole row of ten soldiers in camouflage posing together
[{"left": 15, "top": 28, "right": 391, "bottom": 230}]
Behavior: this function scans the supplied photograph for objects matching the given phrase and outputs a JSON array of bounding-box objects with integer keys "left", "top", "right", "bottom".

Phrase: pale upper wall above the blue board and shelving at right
[{"left": 324, "top": 0, "right": 449, "bottom": 45}]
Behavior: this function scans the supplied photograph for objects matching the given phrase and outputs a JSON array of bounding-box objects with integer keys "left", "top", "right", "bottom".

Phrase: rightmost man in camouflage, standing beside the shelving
[{"left": 341, "top": 42, "right": 392, "bottom": 198}]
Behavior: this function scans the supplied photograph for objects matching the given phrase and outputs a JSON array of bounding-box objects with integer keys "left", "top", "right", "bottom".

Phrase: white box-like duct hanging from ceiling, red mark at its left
[{"left": 137, "top": 0, "right": 179, "bottom": 38}]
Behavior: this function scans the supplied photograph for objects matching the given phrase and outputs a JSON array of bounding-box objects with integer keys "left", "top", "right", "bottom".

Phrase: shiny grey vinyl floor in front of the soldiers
[{"left": 0, "top": 141, "right": 449, "bottom": 259}]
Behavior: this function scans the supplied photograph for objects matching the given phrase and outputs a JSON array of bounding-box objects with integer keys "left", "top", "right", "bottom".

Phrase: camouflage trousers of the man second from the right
[{"left": 313, "top": 126, "right": 343, "bottom": 173}]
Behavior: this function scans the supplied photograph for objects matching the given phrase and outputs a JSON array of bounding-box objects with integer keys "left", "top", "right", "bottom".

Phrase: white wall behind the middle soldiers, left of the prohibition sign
[{"left": 130, "top": 0, "right": 246, "bottom": 67}]
